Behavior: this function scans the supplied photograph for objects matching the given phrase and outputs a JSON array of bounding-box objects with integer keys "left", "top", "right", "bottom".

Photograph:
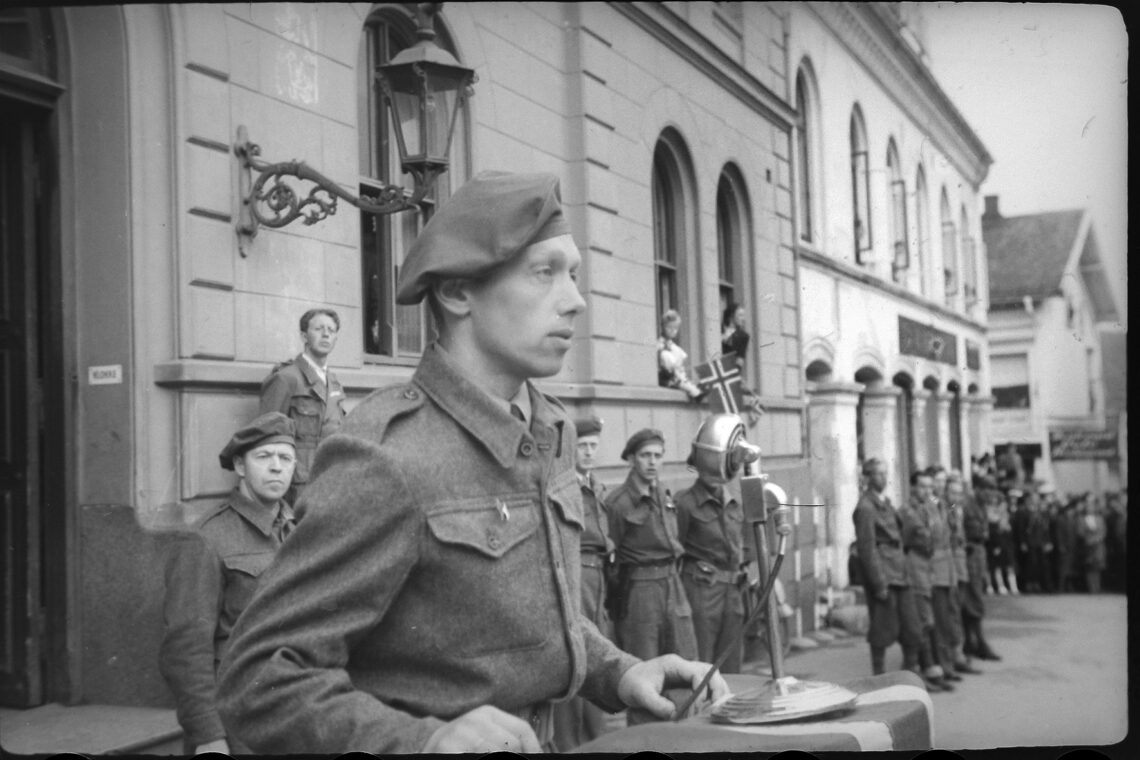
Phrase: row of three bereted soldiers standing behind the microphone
[{"left": 555, "top": 417, "right": 751, "bottom": 751}]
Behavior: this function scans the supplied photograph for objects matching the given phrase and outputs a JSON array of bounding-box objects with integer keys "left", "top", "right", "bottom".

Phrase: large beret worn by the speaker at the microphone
[{"left": 396, "top": 171, "right": 570, "bottom": 304}]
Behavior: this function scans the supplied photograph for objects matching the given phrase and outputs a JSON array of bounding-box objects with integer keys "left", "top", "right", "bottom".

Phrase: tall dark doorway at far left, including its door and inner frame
[{"left": 0, "top": 96, "right": 67, "bottom": 708}]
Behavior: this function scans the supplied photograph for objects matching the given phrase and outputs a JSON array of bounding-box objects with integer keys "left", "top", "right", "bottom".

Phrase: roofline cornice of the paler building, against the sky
[{"left": 805, "top": 2, "right": 993, "bottom": 187}]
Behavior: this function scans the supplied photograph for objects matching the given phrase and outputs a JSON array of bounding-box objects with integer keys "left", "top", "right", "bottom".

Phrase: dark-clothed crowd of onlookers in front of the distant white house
[{"left": 972, "top": 452, "right": 1127, "bottom": 595}]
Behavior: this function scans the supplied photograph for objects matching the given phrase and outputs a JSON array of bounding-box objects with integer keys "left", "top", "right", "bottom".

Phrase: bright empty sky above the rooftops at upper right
[{"left": 923, "top": 2, "right": 1129, "bottom": 324}]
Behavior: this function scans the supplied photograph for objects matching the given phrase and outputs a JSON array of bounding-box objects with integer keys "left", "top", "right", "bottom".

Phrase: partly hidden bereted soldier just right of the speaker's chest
[{"left": 554, "top": 416, "right": 613, "bottom": 752}]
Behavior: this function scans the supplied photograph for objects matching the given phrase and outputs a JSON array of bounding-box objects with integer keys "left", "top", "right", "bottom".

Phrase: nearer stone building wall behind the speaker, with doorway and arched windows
[{"left": 0, "top": 2, "right": 816, "bottom": 706}]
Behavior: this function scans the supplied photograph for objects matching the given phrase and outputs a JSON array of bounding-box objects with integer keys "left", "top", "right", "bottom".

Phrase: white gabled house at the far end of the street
[{"left": 983, "top": 196, "right": 1118, "bottom": 493}]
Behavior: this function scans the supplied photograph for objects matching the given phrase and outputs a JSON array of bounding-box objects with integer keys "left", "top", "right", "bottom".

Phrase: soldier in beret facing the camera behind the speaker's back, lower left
[{"left": 158, "top": 411, "right": 296, "bottom": 754}]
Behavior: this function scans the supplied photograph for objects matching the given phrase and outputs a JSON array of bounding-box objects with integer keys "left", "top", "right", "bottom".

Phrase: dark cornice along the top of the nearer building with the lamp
[{"left": 610, "top": 2, "right": 796, "bottom": 130}]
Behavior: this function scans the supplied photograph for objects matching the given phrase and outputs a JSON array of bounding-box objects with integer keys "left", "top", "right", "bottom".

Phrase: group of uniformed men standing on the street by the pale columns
[{"left": 852, "top": 459, "right": 1000, "bottom": 692}]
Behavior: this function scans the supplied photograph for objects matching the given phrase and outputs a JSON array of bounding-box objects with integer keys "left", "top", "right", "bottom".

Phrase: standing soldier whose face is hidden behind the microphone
[{"left": 676, "top": 446, "right": 748, "bottom": 673}]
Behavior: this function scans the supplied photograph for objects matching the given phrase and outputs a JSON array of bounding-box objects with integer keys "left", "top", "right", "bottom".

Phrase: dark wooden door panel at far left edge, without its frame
[{"left": 0, "top": 98, "right": 46, "bottom": 706}]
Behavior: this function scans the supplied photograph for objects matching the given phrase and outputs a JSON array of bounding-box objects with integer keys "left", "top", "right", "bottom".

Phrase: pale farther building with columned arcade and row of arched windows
[{"left": 788, "top": 2, "right": 992, "bottom": 588}]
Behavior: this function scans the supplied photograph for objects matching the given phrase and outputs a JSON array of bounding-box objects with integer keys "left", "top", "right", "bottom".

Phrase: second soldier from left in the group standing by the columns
[{"left": 898, "top": 471, "right": 954, "bottom": 692}]
